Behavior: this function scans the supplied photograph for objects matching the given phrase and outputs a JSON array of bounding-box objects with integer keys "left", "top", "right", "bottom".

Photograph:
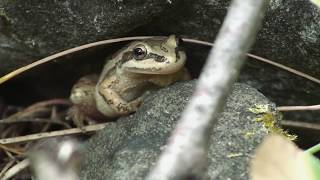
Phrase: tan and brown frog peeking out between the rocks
[{"left": 69, "top": 35, "right": 191, "bottom": 127}]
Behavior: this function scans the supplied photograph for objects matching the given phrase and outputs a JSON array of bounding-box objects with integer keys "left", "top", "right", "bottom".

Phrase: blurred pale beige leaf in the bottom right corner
[{"left": 250, "top": 134, "right": 320, "bottom": 180}]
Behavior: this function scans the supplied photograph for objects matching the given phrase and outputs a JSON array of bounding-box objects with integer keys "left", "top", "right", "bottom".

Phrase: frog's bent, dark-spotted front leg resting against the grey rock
[{"left": 97, "top": 76, "right": 142, "bottom": 117}]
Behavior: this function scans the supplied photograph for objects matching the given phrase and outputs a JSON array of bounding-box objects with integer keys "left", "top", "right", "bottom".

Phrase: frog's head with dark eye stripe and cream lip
[{"left": 119, "top": 35, "right": 186, "bottom": 74}]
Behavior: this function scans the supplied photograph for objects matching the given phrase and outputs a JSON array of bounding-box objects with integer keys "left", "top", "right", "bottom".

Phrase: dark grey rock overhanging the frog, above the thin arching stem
[{"left": 0, "top": 0, "right": 320, "bottom": 77}]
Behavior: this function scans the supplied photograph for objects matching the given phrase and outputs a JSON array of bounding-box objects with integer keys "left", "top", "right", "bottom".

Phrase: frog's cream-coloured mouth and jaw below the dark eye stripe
[{"left": 123, "top": 51, "right": 186, "bottom": 74}]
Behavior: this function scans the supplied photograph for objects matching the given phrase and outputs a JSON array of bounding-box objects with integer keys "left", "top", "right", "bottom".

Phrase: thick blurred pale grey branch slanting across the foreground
[{"left": 147, "top": 0, "right": 268, "bottom": 180}]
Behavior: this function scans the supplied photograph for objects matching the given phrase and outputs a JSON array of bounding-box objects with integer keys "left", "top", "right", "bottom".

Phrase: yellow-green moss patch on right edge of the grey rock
[{"left": 249, "top": 104, "right": 297, "bottom": 140}]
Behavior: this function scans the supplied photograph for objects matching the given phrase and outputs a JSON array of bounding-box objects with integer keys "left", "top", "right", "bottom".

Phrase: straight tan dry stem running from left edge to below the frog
[{"left": 0, "top": 123, "right": 108, "bottom": 144}]
